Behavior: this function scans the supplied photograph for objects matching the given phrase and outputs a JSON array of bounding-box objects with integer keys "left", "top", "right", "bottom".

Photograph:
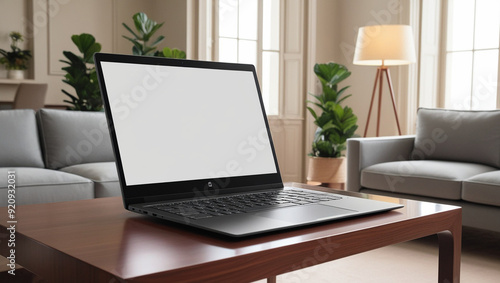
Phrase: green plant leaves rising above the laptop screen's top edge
[{"left": 122, "top": 12, "right": 186, "bottom": 59}]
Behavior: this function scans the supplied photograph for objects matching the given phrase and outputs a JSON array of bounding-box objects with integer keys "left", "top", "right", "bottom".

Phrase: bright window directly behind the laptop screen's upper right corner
[{"left": 214, "top": 0, "right": 281, "bottom": 115}]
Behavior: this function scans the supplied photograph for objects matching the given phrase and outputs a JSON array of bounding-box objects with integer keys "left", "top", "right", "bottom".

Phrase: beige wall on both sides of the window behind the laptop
[{"left": 0, "top": 0, "right": 409, "bottom": 130}]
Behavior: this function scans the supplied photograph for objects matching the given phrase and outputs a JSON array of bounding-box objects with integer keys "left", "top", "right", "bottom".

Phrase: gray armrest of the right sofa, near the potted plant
[{"left": 346, "top": 135, "right": 415, "bottom": 192}]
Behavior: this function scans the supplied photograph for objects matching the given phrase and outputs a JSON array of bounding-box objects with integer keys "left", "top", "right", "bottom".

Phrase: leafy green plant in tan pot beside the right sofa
[{"left": 307, "top": 63, "right": 358, "bottom": 183}]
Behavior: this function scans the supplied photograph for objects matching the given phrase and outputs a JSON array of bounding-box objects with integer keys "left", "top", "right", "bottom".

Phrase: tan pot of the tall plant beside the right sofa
[{"left": 307, "top": 156, "right": 347, "bottom": 183}]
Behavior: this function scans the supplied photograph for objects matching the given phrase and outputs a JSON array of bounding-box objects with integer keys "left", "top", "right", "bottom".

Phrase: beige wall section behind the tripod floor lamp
[{"left": 305, "top": 0, "right": 416, "bottom": 151}]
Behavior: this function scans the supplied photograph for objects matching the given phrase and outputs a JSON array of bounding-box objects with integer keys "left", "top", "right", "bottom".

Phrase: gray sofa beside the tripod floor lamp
[{"left": 346, "top": 108, "right": 500, "bottom": 232}]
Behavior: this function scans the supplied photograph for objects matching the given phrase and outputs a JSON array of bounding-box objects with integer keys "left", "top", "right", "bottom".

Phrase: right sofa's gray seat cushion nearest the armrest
[{"left": 361, "top": 160, "right": 497, "bottom": 200}]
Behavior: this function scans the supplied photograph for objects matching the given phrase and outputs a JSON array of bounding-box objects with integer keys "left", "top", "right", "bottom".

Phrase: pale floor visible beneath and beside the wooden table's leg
[{"left": 255, "top": 227, "right": 500, "bottom": 283}]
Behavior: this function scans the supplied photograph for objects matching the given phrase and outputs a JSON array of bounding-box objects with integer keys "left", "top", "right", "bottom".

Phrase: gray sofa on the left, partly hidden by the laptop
[{"left": 0, "top": 109, "right": 121, "bottom": 206}]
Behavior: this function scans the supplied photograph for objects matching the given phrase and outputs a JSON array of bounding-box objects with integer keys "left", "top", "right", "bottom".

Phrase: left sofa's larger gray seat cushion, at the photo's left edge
[{"left": 0, "top": 167, "right": 94, "bottom": 206}]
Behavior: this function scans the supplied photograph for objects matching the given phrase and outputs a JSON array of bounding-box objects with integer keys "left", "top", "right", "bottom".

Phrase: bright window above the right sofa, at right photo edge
[{"left": 444, "top": 0, "right": 500, "bottom": 110}]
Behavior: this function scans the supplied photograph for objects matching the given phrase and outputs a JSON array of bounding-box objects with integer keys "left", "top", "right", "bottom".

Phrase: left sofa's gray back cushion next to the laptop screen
[{"left": 37, "top": 109, "right": 114, "bottom": 169}]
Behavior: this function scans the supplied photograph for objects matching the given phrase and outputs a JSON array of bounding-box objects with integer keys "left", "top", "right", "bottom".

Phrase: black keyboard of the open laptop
[{"left": 152, "top": 190, "right": 341, "bottom": 219}]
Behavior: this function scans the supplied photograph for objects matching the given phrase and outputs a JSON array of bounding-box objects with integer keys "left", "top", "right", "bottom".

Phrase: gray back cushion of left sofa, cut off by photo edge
[{"left": 0, "top": 109, "right": 44, "bottom": 168}]
